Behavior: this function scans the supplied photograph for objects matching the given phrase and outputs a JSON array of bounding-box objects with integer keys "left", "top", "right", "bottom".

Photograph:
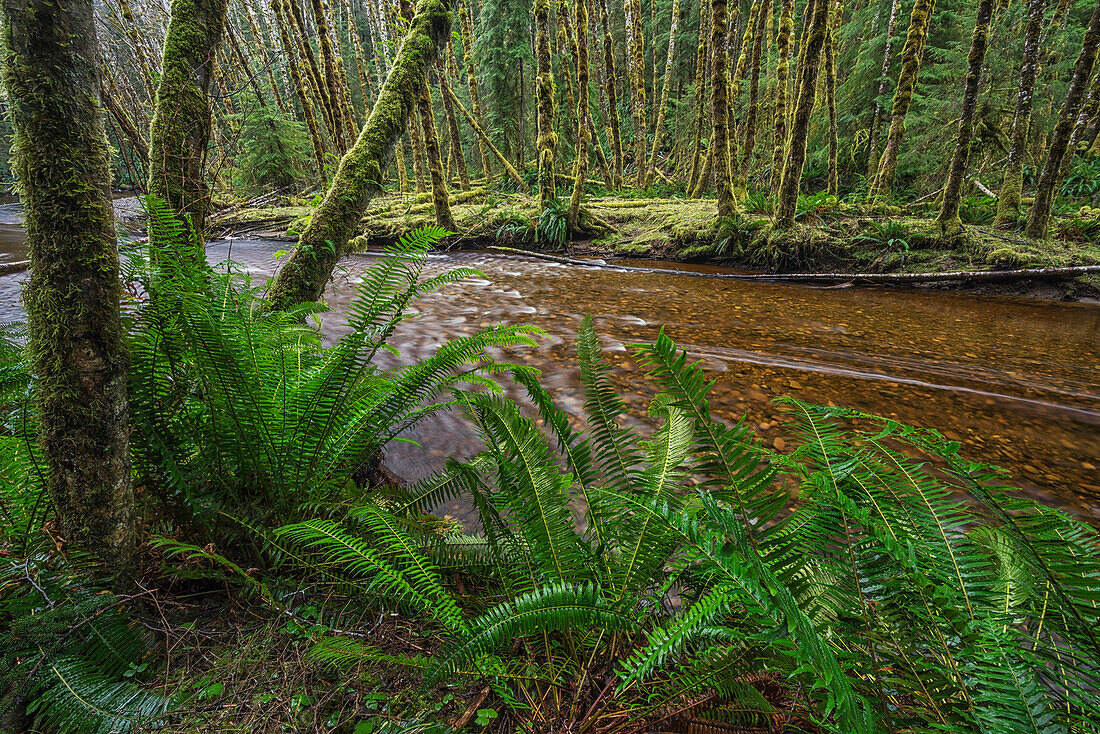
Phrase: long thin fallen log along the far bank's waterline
[{"left": 488, "top": 245, "right": 1100, "bottom": 283}]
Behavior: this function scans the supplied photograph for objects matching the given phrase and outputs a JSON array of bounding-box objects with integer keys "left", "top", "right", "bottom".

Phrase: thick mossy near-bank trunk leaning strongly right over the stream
[{"left": 268, "top": 0, "right": 451, "bottom": 308}]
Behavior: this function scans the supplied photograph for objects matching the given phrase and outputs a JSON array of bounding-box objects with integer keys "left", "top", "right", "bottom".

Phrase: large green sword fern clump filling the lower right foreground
[{"left": 282, "top": 321, "right": 1100, "bottom": 732}]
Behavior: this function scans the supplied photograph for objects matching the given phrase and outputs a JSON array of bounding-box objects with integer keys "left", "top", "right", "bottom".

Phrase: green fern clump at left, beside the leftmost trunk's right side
[{"left": 130, "top": 213, "right": 538, "bottom": 539}]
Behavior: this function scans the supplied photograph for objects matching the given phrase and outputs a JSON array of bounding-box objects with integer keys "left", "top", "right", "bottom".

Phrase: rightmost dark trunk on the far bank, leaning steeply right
[{"left": 1024, "top": 0, "right": 1100, "bottom": 240}]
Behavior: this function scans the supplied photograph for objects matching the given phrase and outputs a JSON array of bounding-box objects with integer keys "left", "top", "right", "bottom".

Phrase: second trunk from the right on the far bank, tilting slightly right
[{"left": 993, "top": 0, "right": 1046, "bottom": 229}]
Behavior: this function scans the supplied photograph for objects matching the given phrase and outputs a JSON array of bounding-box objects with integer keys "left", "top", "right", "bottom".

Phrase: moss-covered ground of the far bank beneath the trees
[{"left": 212, "top": 188, "right": 1100, "bottom": 300}]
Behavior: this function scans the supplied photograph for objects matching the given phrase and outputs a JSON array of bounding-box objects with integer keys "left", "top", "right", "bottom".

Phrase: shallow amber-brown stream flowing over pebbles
[{"left": 0, "top": 206, "right": 1100, "bottom": 522}]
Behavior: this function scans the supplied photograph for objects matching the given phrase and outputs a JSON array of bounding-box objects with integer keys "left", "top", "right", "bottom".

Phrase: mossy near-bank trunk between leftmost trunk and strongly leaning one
[{"left": 149, "top": 0, "right": 227, "bottom": 253}]
